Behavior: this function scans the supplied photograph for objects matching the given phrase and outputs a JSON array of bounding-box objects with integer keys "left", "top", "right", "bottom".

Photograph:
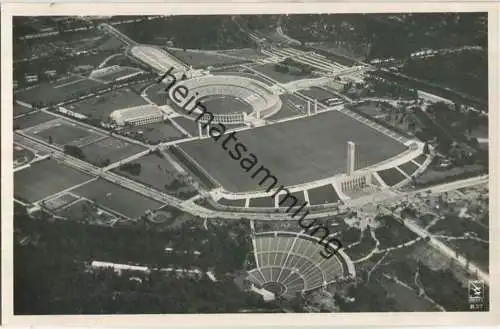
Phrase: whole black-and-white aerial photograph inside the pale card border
[{"left": 11, "top": 12, "right": 490, "bottom": 315}]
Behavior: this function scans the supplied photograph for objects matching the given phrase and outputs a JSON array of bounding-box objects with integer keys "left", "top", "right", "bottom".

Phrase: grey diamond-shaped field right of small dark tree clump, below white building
[{"left": 82, "top": 137, "right": 144, "bottom": 166}]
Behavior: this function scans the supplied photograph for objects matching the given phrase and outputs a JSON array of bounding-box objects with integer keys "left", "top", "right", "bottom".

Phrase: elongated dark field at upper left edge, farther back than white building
[{"left": 14, "top": 76, "right": 103, "bottom": 103}]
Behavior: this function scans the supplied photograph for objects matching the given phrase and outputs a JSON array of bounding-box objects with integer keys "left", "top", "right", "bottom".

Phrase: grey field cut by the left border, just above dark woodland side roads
[{"left": 14, "top": 160, "right": 92, "bottom": 202}]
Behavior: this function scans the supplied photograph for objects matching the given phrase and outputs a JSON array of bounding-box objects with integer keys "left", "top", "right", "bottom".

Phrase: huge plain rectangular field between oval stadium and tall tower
[{"left": 179, "top": 111, "right": 406, "bottom": 192}]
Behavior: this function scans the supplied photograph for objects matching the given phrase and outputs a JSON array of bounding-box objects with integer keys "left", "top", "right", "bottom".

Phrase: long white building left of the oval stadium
[{"left": 110, "top": 104, "right": 165, "bottom": 126}]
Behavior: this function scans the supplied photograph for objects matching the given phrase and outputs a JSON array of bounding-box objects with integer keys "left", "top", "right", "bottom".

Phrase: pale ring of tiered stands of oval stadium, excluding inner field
[{"left": 169, "top": 75, "right": 282, "bottom": 124}]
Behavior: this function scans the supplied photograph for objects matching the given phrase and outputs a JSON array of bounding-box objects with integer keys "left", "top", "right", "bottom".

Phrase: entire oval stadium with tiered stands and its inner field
[{"left": 169, "top": 75, "right": 281, "bottom": 124}]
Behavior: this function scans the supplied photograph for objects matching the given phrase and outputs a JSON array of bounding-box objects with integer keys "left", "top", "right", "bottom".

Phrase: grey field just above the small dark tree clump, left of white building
[{"left": 26, "top": 119, "right": 104, "bottom": 147}]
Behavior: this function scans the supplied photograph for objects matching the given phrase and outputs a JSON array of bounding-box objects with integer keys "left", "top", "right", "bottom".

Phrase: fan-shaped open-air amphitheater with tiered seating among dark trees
[{"left": 247, "top": 232, "right": 356, "bottom": 298}]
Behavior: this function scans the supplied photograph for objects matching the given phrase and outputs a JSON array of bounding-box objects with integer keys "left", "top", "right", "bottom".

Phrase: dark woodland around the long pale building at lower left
[{"left": 14, "top": 206, "right": 266, "bottom": 314}]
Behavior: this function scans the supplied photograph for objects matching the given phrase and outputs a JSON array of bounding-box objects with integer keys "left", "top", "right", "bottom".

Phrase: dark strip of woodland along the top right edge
[{"left": 283, "top": 13, "right": 487, "bottom": 58}]
